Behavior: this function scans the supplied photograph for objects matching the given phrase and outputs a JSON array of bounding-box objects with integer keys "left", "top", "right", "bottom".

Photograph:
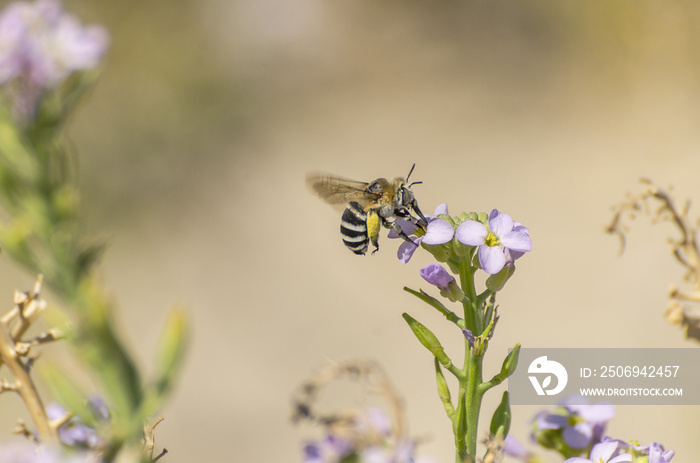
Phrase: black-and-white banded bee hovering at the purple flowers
[{"left": 306, "top": 164, "right": 428, "bottom": 255}]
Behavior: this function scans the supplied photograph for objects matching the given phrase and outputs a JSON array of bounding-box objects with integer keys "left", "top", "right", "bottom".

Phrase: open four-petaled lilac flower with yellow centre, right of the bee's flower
[{"left": 455, "top": 209, "right": 532, "bottom": 275}]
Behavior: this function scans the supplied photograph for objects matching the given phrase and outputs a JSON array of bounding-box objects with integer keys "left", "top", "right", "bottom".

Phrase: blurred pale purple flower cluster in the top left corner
[{"left": 0, "top": 0, "right": 109, "bottom": 118}]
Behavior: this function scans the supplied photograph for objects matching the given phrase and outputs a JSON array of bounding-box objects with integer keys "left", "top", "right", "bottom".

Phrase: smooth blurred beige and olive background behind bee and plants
[{"left": 0, "top": 0, "right": 700, "bottom": 463}]
